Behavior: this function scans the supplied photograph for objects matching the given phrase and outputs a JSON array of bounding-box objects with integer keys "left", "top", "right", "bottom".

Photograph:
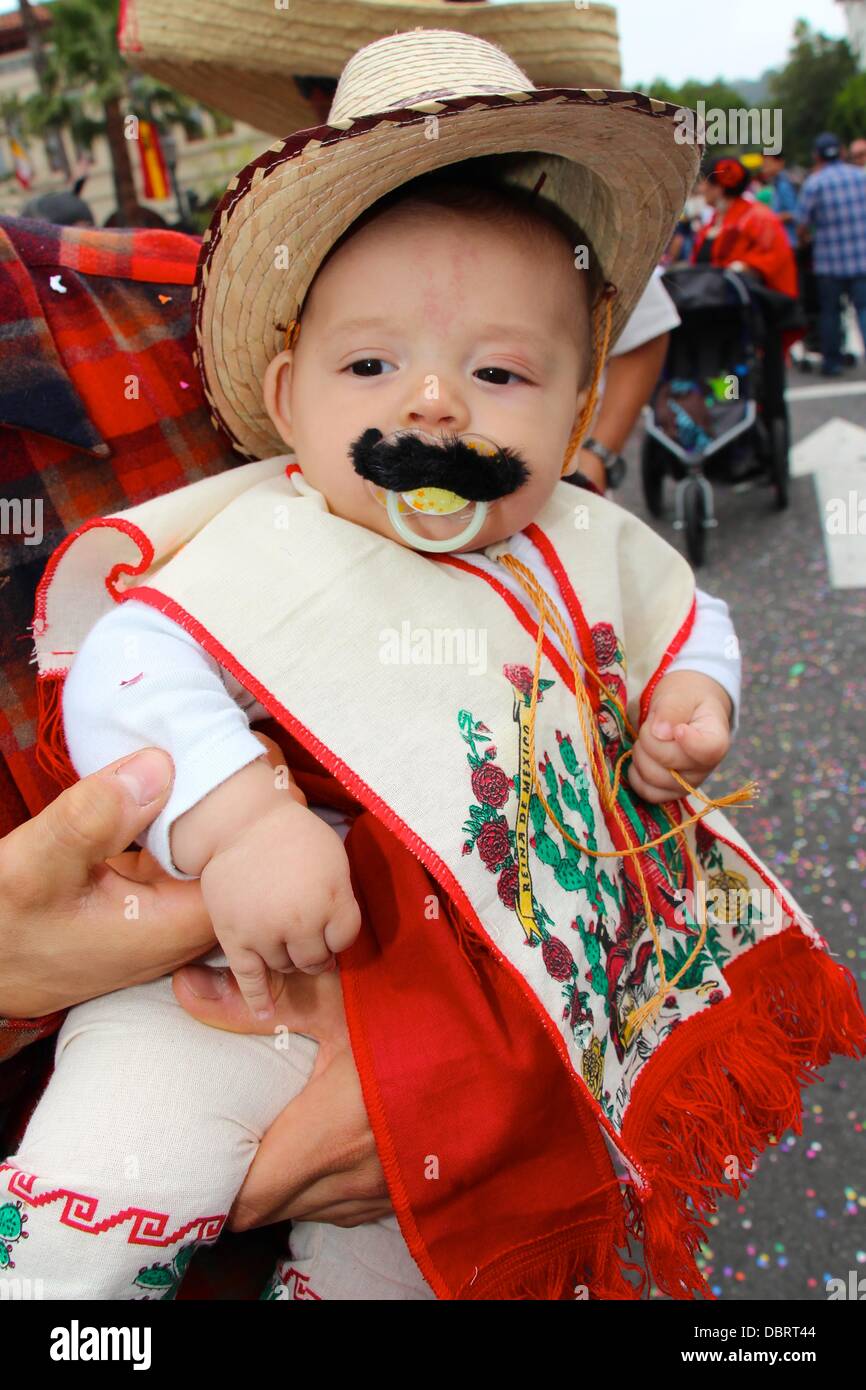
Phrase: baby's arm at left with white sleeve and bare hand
[{"left": 63, "top": 599, "right": 357, "bottom": 1011}]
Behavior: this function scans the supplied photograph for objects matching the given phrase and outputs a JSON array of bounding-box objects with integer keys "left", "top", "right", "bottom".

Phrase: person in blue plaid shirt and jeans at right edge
[{"left": 798, "top": 132, "right": 866, "bottom": 377}]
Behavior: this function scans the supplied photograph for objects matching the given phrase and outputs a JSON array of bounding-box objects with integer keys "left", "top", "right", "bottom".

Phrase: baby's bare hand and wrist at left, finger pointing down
[{"left": 171, "top": 760, "right": 361, "bottom": 1019}]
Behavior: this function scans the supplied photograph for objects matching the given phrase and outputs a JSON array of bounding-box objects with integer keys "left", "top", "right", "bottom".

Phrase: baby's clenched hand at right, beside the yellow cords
[{"left": 628, "top": 671, "right": 733, "bottom": 802}]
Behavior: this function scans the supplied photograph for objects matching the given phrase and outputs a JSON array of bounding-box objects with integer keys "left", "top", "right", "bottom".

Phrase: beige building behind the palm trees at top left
[{"left": 0, "top": 4, "right": 274, "bottom": 225}]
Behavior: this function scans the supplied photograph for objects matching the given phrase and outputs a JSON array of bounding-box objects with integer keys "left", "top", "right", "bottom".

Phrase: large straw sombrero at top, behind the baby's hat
[{"left": 118, "top": 0, "right": 620, "bottom": 135}]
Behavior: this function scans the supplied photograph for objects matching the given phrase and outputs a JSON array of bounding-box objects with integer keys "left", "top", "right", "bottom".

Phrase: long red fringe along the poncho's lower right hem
[{"left": 623, "top": 927, "right": 866, "bottom": 1301}]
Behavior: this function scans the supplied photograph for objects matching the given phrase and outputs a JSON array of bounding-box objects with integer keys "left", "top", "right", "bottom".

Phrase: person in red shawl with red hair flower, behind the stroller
[{"left": 692, "top": 156, "right": 798, "bottom": 297}]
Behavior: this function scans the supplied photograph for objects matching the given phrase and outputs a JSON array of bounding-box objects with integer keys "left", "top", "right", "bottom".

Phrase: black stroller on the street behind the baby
[{"left": 641, "top": 265, "right": 801, "bottom": 566}]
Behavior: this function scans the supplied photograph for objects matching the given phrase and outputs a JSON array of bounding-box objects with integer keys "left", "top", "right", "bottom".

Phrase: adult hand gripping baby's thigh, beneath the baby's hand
[{"left": 174, "top": 965, "right": 392, "bottom": 1230}]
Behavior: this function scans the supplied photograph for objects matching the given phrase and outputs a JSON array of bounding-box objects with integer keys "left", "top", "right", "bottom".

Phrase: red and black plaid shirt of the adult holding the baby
[{"left": 0, "top": 217, "right": 242, "bottom": 1050}]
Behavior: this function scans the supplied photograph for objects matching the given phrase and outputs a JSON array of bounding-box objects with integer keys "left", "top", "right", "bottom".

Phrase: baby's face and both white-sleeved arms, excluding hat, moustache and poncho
[{"left": 76, "top": 173, "right": 737, "bottom": 1017}]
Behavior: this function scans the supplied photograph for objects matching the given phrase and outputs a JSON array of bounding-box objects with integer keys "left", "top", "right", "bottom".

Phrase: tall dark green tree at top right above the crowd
[{"left": 770, "top": 19, "right": 858, "bottom": 164}]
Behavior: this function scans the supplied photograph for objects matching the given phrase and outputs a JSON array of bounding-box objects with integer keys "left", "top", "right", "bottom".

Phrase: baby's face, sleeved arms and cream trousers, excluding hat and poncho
[{"left": 3, "top": 165, "right": 738, "bottom": 1298}]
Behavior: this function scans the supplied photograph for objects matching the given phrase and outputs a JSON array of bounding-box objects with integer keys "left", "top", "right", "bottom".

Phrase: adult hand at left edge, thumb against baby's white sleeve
[{"left": 0, "top": 748, "right": 215, "bottom": 1019}]
